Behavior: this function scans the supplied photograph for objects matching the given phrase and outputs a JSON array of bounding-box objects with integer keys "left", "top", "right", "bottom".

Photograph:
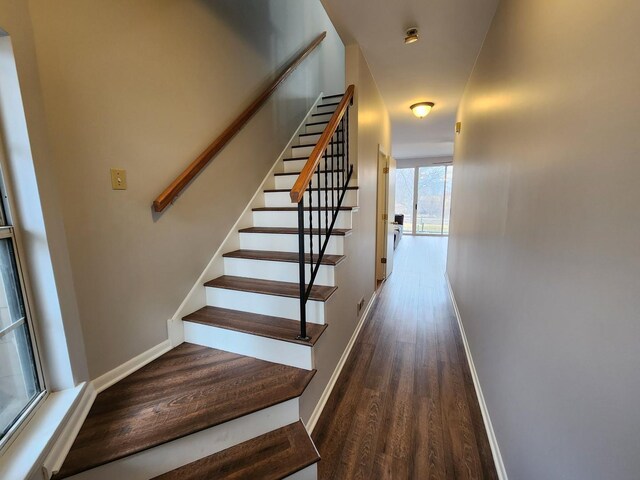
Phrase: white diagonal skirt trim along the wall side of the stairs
[{"left": 169, "top": 92, "right": 324, "bottom": 332}]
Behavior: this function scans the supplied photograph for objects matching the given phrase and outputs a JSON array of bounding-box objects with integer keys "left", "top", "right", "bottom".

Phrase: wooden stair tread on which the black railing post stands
[{"left": 183, "top": 306, "right": 327, "bottom": 347}]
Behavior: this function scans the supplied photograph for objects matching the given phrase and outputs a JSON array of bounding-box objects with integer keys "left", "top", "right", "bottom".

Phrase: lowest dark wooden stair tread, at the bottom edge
[{"left": 152, "top": 421, "right": 320, "bottom": 480}]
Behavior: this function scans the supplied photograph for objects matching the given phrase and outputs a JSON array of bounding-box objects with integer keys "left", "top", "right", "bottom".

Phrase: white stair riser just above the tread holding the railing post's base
[{"left": 205, "top": 287, "right": 324, "bottom": 325}]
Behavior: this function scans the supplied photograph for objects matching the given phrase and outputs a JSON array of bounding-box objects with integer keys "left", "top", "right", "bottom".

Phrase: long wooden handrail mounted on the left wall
[{"left": 153, "top": 32, "right": 327, "bottom": 212}]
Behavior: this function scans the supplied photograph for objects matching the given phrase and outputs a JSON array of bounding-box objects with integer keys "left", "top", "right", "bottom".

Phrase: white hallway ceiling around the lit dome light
[{"left": 322, "top": 0, "right": 499, "bottom": 158}]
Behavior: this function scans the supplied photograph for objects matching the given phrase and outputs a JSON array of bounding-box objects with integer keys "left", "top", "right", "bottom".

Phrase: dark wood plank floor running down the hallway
[{"left": 312, "top": 236, "right": 498, "bottom": 480}]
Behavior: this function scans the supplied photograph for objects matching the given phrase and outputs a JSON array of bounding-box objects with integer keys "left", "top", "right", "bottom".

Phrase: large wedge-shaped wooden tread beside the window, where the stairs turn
[{"left": 54, "top": 343, "right": 315, "bottom": 479}]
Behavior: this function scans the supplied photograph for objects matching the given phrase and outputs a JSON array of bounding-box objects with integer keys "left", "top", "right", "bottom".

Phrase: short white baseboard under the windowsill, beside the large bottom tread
[{"left": 42, "top": 383, "right": 96, "bottom": 479}]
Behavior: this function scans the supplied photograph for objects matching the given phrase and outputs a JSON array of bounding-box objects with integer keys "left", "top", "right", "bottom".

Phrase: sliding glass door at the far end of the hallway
[{"left": 396, "top": 165, "right": 453, "bottom": 235}]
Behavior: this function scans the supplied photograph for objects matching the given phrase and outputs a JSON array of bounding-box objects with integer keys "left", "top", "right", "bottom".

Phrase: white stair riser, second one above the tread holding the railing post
[{"left": 224, "top": 256, "right": 335, "bottom": 287}]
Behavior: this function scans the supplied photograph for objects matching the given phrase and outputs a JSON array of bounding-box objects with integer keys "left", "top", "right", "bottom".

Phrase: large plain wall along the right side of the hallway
[{"left": 448, "top": 0, "right": 640, "bottom": 480}]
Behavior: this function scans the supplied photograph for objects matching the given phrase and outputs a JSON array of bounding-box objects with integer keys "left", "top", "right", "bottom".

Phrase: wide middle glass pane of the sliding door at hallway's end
[{"left": 416, "top": 166, "right": 446, "bottom": 235}]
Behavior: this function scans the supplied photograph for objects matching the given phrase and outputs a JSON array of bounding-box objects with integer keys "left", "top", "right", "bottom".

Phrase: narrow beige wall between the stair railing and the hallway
[{"left": 301, "top": 45, "right": 391, "bottom": 421}]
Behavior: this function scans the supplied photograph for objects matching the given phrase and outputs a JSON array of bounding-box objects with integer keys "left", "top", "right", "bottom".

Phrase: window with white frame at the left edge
[{"left": 0, "top": 188, "right": 43, "bottom": 446}]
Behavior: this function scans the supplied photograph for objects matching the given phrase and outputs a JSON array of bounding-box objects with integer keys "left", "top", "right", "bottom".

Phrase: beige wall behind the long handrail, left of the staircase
[{"left": 11, "top": 0, "right": 344, "bottom": 378}]
